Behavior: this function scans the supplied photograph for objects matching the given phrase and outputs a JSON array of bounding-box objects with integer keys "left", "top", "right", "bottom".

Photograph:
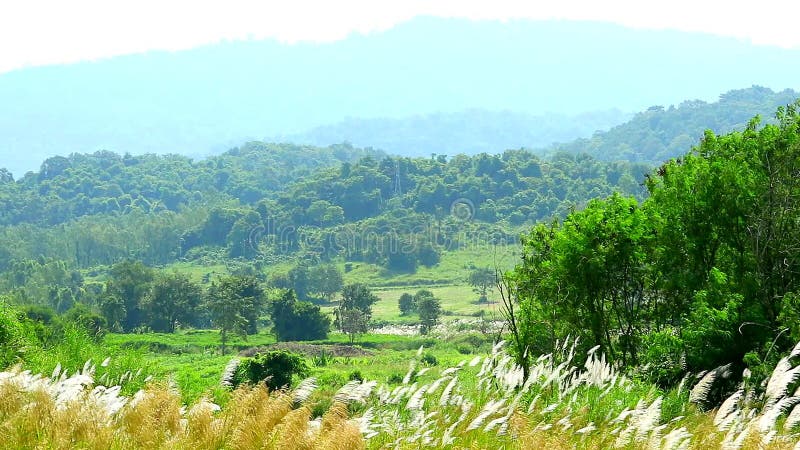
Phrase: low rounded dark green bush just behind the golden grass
[{"left": 233, "top": 350, "right": 308, "bottom": 390}]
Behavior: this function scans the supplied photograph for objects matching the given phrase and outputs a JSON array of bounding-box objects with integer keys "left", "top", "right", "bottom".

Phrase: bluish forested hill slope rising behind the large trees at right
[{"left": 551, "top": 86, "right": 800, "bottom": 164}]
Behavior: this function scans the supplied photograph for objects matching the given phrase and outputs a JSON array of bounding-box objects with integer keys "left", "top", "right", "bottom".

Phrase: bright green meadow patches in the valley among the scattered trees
[{"left": 125, "top": 246, "right": 518, "bottom": 402}]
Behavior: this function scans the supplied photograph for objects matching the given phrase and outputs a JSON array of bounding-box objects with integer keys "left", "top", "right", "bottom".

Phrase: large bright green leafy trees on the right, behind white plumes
[{"left": 503, "top": 102, "right": 800, "bottom": 385}]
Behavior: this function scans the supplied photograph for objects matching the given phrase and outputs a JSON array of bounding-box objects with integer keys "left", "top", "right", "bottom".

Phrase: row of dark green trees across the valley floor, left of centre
[{"left": 0, "top": 255, "right": 440, "bottom": 352}]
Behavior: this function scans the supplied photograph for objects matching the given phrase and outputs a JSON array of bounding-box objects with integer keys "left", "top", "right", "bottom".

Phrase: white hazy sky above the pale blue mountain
[{"left": 0, "top": 0, "right": 800, "bottom": 72}]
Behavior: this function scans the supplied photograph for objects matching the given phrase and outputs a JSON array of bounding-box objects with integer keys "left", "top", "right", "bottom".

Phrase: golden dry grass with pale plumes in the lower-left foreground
[{"left": 0, "top": 370, "right": 364, "bottom": 450}]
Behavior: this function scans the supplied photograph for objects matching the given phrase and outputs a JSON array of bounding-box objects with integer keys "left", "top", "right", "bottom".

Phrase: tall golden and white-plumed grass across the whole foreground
[{"left": 0, "top": 343, "right": 800, "bottom": 449}]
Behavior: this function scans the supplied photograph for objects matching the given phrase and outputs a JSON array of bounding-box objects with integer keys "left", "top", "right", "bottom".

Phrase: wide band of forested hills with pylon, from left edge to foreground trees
[{"left": 0, "top": 143, "right": 649, "bottom": 270}]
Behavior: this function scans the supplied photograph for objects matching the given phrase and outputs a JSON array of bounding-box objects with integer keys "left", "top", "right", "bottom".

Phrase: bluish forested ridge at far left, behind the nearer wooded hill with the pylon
[{"left": 0, "top": 142, "right": 384, "bottom": 229}]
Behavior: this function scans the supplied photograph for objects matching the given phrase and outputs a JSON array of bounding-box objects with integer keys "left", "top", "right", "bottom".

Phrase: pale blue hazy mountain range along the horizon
[{"left": 0, "top": 18, "right": 800, "bottom": 174}]
